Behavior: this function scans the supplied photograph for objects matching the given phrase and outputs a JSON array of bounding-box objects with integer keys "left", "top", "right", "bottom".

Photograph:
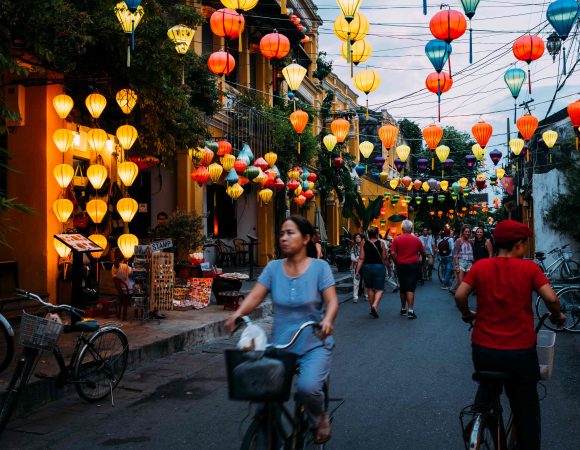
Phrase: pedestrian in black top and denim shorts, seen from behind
[{"left": 355, "top": 228, "right": 387, "bottom": 319}]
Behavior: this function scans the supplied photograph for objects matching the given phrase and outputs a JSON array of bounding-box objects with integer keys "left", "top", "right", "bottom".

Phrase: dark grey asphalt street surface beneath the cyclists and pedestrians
[{"left": 0, "top": 282, "right": 580, "bottom": 450}]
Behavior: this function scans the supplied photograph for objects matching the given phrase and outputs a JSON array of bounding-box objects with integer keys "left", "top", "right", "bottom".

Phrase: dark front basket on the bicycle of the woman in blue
[{"left": 225, "top": 349, "right": 297, "bottom": 402}]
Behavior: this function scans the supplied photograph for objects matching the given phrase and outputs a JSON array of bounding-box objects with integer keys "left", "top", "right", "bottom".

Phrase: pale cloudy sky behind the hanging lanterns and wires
[{"left": 315, "top": 0, "right": 580, "bottom": 158}]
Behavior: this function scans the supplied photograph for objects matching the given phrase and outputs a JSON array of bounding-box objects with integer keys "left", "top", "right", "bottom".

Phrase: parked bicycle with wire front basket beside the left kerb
[{"left": 0, "top": 290, "right": 129, "bottom": 432}]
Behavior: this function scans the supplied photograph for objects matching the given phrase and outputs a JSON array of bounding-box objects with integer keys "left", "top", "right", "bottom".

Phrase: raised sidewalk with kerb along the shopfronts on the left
[{"left": 0, "top": 267, "right": 352, "bottom": 411}]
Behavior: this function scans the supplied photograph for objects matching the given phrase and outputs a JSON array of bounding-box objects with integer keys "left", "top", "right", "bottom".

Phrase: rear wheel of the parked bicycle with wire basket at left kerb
[{"left": 74, "top": 328, "right": 129, "bottom": 402}]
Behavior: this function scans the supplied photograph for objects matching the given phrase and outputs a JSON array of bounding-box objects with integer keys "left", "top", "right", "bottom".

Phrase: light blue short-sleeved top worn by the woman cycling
[{"left": 258, "top": 259, "right": 335, "bottom": 355}]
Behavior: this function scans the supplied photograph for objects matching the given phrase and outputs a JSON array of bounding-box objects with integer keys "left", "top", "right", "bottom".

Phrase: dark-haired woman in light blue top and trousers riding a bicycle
[{"left": 226, "top": 216, "right": 338, "bottom": 443}]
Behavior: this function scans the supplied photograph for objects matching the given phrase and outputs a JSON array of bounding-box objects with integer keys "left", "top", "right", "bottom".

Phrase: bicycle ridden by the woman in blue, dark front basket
[{"left": 225, "top": 317, "right": 343, "bottom": 450}]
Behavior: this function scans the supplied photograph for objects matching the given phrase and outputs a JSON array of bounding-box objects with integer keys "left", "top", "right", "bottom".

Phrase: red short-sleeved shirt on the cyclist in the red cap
[{"left": 463, "top": 257, "right": 549, "bottom": 350}]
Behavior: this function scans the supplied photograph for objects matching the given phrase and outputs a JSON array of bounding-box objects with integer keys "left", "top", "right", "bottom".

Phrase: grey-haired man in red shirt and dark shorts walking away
[{"left": 391, "top": 220, "right": 425, "bottom": 319}]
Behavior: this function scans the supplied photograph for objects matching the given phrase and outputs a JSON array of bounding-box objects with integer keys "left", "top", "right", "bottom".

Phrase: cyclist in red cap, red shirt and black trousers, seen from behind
[{"left": 455, "top": 220, "right": 566, "bottom": 450}]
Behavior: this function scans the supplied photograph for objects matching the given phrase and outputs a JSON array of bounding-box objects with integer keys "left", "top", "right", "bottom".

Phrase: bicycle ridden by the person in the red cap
[{"left": 459, "top": 313, "right": 555, "bottom": 450}]
